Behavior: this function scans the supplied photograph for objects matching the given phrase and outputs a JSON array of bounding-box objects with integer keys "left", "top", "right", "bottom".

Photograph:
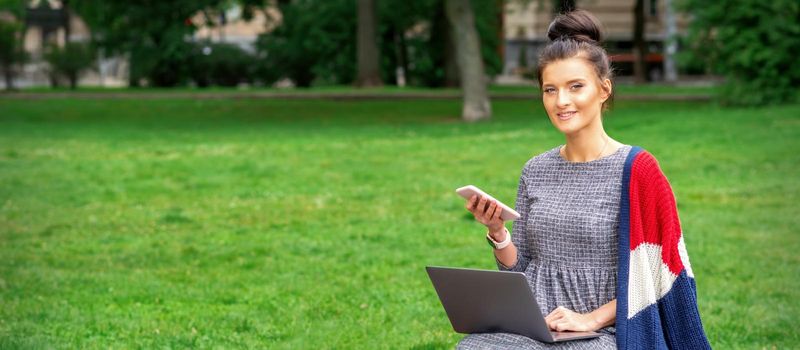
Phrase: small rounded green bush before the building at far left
[{"left": 44, "top": 42, "right": 95, "bottom": 90}]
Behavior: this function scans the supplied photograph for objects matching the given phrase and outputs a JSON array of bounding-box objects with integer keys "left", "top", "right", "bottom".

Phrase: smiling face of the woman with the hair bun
[{"left": 542, "top": 57, "right": 611, "bottom": 135}]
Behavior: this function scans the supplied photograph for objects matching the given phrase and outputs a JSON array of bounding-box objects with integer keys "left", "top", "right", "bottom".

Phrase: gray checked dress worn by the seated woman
[{"left": 457, "top": 145, "right": 631, "bottom": 349}]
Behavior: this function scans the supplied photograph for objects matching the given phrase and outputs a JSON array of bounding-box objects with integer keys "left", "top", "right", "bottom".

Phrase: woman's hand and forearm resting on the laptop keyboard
[{"left": 544, "top": 299, "right": 617, "bottom": 332}]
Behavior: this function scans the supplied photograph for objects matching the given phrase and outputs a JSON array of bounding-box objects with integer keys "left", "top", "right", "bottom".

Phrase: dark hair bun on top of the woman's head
[{"left": 547, "top": 10, "right": 603, "bottom": 45}]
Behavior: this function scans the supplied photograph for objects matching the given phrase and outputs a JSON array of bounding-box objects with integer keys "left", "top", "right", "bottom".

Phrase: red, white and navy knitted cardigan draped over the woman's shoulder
[{"left": 616, "top": 147, "right": 711, "bottom": 349}]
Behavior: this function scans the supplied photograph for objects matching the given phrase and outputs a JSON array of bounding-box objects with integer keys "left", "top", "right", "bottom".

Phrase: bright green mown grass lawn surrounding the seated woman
[{"left": 0, "top": 94, "right": 800, "bottom": 349}]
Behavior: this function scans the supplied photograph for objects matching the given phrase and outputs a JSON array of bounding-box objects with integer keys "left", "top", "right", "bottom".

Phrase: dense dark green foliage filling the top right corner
[{"left": 681, "top": 0, "right": 800, "bottom": 105}]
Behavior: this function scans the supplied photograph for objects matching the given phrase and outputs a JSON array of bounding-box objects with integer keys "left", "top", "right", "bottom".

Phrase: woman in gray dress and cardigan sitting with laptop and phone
[{"left": 458, "top": 10, "right": 709, "bottom": 349}]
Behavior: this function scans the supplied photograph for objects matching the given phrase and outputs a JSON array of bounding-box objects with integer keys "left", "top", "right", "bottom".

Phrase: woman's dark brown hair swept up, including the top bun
[{"left": 536, "top": 10, "right": 614, "bottom": 108}]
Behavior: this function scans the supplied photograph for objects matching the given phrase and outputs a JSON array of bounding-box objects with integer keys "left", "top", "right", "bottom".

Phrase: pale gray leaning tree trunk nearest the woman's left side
[{"left": 445, "top": 0, "right": 492, "bottom": 122}]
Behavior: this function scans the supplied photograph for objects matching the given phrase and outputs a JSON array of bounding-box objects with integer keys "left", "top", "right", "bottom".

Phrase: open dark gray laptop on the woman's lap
[{"left": 426, "top": 266, "right": 601, "bottom": 343}]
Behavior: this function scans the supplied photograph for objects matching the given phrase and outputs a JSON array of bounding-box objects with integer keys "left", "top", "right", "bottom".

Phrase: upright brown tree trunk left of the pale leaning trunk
[{"left": 356, "top": 0, "right": 383, "bottom": 87}]
